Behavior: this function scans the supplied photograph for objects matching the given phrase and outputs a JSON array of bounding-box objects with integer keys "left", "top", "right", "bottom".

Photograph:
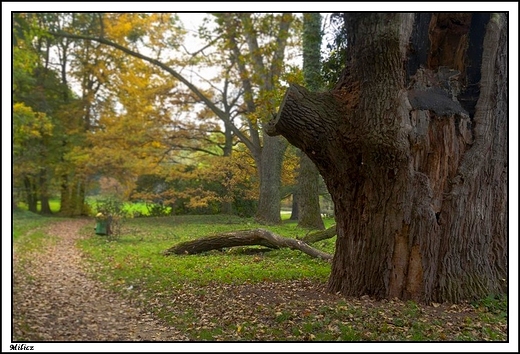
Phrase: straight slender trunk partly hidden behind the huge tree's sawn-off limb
[{"left": 298, "top": 13, "right": 325, "bottom": 230}]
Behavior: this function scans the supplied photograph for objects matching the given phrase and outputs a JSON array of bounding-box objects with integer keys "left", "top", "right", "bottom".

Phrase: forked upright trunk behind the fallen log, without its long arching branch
[{"left": 219, "top": 13, "right": 294, "bottom": 224}]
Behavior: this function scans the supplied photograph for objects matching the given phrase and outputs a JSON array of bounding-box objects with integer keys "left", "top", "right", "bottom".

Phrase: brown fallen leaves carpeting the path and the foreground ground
[{"left": 13, "top": 220, "right": 507, "bottom": 341}]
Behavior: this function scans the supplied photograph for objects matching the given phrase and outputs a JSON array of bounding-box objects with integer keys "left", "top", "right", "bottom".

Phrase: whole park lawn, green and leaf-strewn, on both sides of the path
[{"left": 13, "top": 214, "right": 508, "bottom": 341}]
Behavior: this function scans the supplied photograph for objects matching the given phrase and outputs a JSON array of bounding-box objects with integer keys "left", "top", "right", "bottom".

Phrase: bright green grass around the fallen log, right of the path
[{"left": 81, "top": 215, "right": 333, "bottom": 292}]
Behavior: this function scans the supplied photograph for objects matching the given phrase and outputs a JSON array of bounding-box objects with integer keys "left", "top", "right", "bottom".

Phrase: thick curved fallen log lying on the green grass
[{"left": 164, "top": 229, "right": 332, "bottom": 260}]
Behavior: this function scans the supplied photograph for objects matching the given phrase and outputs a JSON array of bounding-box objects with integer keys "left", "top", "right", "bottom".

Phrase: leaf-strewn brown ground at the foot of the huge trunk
[{"left": 135, "top": 280, "right": 507, "bottom": 341}]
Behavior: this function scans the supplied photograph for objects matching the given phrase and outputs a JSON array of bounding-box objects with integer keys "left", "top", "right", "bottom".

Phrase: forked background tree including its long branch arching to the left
[{"left": 51, "top": 14, "right": 300, "bottom": 222}]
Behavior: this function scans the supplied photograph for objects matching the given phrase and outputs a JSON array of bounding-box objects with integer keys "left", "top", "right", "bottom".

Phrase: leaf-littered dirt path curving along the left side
[{"left": 13, "top": 220, "right": 187, "bottom": 341}]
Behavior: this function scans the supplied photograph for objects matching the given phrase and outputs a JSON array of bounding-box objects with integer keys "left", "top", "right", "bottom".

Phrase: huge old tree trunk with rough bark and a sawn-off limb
[{"left": 267, "top": 13, "right": 508, "bottom": 302}]
